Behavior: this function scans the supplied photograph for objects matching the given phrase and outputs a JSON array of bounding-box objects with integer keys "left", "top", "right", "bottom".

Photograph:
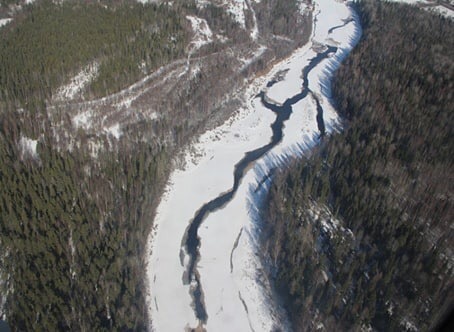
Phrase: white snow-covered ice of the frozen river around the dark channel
[{"left": 147, "top": 0, "right": 360, "bottom": 331}]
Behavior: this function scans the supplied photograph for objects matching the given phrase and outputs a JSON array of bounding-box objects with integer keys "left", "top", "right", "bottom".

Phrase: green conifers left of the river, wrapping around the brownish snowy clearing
[{"left": 0, "top": 1, "right": 188, "bottom": 331}]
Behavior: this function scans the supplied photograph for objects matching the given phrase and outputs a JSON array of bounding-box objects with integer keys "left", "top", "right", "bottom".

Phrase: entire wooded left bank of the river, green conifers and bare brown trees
[{"left": 0, "top": 0, "right": 311, "bottom": 331}]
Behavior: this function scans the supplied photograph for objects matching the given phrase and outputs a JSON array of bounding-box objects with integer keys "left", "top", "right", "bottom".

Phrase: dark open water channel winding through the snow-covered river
[{"left": 180, "top": 46, "right": 337, "bottom": 323}]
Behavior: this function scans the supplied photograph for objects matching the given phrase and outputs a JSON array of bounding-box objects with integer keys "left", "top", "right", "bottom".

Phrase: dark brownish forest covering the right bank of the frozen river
[{"left": 264, "top": 0, "right": 454, "bottom": 331}]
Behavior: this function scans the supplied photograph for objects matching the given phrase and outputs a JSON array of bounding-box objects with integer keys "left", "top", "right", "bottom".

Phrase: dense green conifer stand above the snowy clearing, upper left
[{"left": 0, "top": 0, "right": 188, "bottom": 108}]
